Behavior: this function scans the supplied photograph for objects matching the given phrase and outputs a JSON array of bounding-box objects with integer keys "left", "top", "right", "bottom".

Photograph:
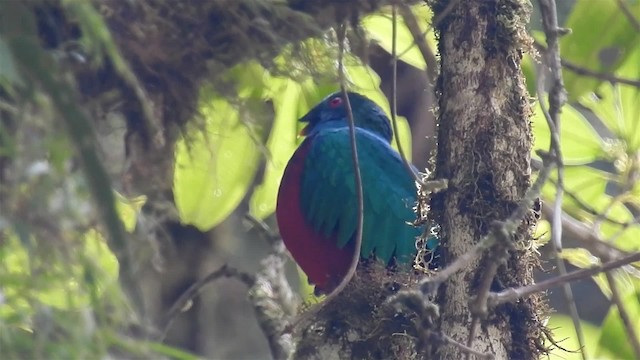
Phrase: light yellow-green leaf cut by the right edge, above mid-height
[{"left": 580, "top": 46, "right": 640, "bottom": 153}]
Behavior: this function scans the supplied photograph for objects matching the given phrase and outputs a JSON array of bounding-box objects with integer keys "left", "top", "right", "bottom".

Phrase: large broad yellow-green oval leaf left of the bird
[{"left": 173, "top": 93, "right": 260, "bottom": 231}]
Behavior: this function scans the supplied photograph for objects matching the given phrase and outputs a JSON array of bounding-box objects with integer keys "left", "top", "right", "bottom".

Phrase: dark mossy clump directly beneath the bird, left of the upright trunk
[{"left": 295, "top": 263, "right": 418, "bottom": 359}]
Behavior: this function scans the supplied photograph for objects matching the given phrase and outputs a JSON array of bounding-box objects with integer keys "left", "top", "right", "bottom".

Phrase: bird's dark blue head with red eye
[{"left": 300, "top": 91, "right": 393, "bottom": 142}]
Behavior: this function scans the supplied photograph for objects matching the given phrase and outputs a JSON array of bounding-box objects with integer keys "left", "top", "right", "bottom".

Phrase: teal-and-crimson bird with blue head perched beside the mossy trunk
[{"left": 276, "top": 91, "right": 432, "bottom": 294}]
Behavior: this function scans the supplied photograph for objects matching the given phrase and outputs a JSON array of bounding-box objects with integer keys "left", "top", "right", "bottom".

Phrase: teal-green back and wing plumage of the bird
[{"left": 301, "top": 127, "right": 421, "bottom": 263}]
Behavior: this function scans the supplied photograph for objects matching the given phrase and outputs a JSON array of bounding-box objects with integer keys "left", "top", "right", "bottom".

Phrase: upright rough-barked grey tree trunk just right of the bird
[{"left": 433, "top": 0, "right": 542, "bottom": 359}]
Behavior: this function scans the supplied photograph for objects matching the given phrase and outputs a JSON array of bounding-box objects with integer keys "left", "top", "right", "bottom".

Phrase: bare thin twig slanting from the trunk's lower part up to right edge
[{"left": 488, "top": 252, "right": 640, "bottom": 307}]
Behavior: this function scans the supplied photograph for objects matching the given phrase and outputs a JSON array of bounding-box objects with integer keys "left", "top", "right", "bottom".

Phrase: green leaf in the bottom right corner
[{"left": 598, "top": 293, "right": 640, "bottom": 359}]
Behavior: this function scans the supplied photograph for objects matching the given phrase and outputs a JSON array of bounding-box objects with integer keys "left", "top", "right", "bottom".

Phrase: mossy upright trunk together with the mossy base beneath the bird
[{"left": 297, "top": 0, "right": 545, "bottom": 359}]
